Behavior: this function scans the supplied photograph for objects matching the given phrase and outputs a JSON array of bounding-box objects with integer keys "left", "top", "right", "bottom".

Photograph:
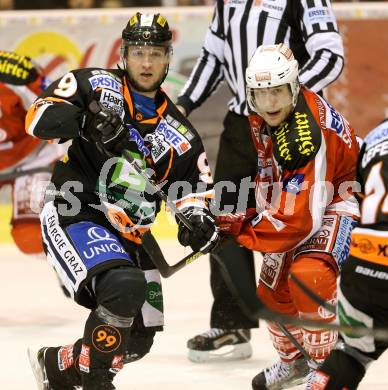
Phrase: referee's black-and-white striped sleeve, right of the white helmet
[{"left": 299, "top": 0, "right": 344, "bottom": 92}]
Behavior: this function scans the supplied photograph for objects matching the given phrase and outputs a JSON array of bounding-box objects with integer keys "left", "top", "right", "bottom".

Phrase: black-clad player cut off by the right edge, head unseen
[{"left": 311, "top": 119, "right": 388, "bottom": 390}]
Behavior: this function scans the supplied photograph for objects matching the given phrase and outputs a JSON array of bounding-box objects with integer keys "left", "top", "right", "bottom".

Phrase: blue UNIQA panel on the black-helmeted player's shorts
[{"left": 66, "top": 222, "right": 132, "bottom": 270}]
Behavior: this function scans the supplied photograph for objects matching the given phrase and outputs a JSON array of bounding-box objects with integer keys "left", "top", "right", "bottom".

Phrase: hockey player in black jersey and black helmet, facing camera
[{"left": 26, "top": 13, "right": 218, "bottom": 390}]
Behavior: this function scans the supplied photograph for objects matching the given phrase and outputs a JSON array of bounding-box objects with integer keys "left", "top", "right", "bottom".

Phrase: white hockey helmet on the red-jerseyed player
[{"left": 245, "top": 43, "right": 300, "bottom": 114}]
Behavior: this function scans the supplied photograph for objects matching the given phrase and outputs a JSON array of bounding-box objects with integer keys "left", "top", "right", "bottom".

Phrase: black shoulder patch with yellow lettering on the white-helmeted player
[{"left": 271, "top": 94, "right": 322, "bottom": 170}]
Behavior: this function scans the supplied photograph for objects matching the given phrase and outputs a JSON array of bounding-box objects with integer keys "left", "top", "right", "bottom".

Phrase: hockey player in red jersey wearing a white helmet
[{"left": 219, "top": 44, "right": 358, "bottom": 390}]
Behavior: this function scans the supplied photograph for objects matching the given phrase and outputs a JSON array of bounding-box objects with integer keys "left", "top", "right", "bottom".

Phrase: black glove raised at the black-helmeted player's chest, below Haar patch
[{"left": 89, "top": 100, "right": 130, "bottom": 155}]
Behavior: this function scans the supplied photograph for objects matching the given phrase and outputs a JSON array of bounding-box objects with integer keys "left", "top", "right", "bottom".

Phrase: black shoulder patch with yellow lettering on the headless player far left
[{"left": 0, "top": 51, "right": 39, "bottom": 85}]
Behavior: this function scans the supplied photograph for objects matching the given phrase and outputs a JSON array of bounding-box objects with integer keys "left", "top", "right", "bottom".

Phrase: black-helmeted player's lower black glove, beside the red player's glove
[{"left": 178, "top": 207, "right": 219, "bottom": 254}]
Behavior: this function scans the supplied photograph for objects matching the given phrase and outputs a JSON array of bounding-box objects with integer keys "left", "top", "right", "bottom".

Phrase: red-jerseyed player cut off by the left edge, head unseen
[{"left": 0, "top": 51, "right": 63, "bottom": 255}]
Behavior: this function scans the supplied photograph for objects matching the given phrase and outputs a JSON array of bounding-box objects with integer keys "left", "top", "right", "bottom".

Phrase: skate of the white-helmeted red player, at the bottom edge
[{"left": 252, "top": 357, "right": 310, "bottom": 390}]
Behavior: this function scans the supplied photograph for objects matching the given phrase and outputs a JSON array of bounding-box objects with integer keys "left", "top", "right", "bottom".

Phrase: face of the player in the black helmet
[{"left": 127, "top": 46, "right": 170, "bottom": 97}]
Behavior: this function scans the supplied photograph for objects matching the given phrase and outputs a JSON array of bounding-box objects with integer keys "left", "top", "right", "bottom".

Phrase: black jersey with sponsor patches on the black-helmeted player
[{"left": 26, "top": 68, "right": 213, "bottom": 238}]
